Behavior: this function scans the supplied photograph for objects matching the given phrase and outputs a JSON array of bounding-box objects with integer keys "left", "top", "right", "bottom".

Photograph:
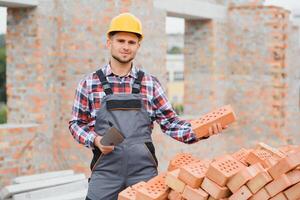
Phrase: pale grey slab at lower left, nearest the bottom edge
[{"left": 13, "top": 179, "right": 88, "bottom": 200}]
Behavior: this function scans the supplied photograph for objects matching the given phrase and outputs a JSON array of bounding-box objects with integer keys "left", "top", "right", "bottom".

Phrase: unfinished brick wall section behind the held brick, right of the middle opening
[{"left": 177, "top": 5, "right": 299, "bottom": 173}]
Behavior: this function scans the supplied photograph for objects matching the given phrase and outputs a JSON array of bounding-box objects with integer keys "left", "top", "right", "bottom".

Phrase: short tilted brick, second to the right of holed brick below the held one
[{"left": 246, "top": 170, "right": 273, "bottom": 194}]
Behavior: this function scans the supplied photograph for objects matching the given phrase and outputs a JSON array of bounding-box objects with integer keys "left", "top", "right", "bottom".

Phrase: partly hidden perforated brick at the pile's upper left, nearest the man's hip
[{"left": 168, "top": 153, "right": 200, "bottom": 171}]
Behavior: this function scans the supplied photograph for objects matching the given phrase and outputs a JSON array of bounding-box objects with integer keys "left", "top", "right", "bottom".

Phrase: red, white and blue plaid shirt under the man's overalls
[{"left": 69, "top": 65, "right": 195, "bottom": 148}]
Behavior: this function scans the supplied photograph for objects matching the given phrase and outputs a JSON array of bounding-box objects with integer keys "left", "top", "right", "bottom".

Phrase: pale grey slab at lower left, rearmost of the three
[{"left": 13, "top": 170, "right": 74, "bottom": 183}]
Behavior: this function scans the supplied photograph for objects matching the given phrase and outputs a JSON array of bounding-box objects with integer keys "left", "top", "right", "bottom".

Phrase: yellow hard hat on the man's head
[{"left": 107, "top": 13, "right": 143, "bottom": 39}]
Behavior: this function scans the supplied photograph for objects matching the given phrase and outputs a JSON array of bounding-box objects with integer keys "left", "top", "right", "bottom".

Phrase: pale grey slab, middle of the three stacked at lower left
[{"left": 0, "top": 174, "right": 85, "bottom": 199}]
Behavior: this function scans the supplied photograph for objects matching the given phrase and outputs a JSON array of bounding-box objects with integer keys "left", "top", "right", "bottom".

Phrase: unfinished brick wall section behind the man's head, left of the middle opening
[{"left": 0, "top": 0, "right": 167, "bottom": 187}]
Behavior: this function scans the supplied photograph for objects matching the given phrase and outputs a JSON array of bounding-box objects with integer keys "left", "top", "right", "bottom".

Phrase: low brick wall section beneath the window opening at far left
[{"left": 0, "top": 124, "right": 38, "bottom": 187}]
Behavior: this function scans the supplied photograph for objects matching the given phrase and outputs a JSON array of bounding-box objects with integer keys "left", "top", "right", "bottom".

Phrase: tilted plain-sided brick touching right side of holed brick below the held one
[{"left": 227, "top": 163, "right": 264, "bottom": 193}]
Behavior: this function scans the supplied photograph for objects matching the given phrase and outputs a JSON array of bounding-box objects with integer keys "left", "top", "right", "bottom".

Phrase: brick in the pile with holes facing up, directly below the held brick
[{"left": 206, "top": 155, "right": 246, "bottom": 186}]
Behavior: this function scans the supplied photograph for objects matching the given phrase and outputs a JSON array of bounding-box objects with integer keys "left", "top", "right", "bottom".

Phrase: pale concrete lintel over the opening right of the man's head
[{"left": 154, "top": 0, "right": 227, "bottom": 20}]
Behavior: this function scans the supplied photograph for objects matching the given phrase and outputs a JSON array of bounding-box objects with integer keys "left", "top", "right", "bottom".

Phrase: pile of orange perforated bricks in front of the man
[{"left": 118, "top": 143, "right": 300, "bottom": 200}]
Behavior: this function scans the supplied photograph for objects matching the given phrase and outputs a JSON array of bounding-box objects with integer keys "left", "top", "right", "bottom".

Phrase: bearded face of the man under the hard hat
[{"left": 106, "top": 32, "right": 140, "bottom": 64}]
